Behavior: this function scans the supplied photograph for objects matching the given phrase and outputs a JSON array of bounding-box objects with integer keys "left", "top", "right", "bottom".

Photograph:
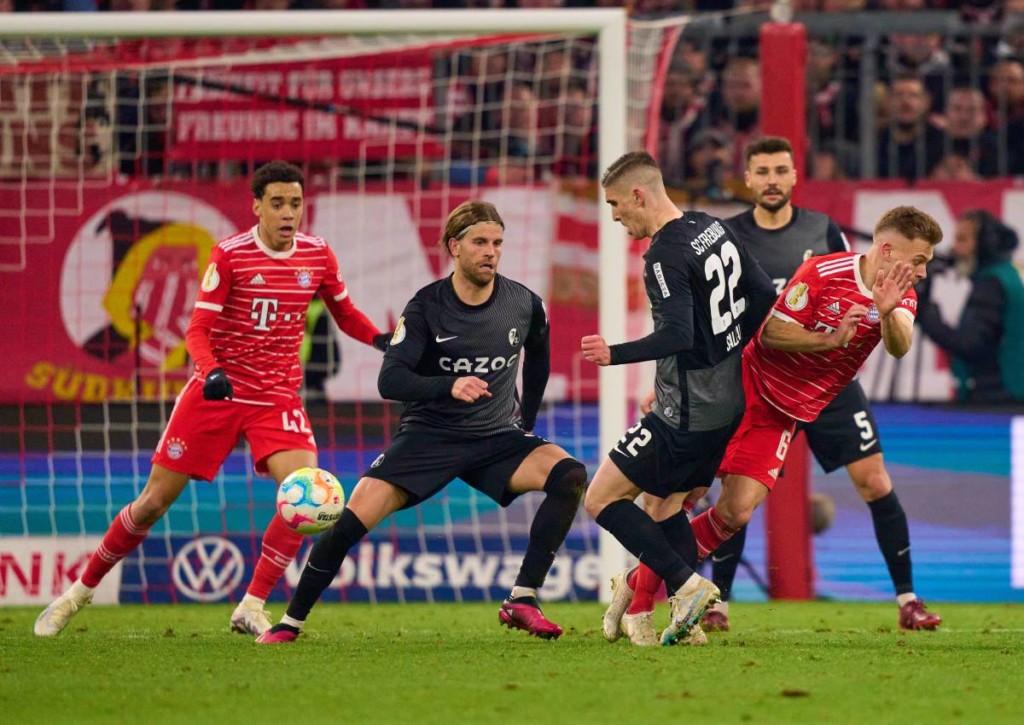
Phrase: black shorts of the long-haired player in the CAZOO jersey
[{"left": 362, "top": 428, "right": 551, "bottom": 508}]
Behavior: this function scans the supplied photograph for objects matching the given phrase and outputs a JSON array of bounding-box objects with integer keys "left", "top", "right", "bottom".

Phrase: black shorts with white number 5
[{"left": 797, "top": 380, "right": 882, "bottom": 473}]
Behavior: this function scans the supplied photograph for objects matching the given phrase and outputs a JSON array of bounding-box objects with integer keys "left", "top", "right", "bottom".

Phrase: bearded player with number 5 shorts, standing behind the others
[{"left": 703, "top": 136, "right": 942, "bottom": 631}]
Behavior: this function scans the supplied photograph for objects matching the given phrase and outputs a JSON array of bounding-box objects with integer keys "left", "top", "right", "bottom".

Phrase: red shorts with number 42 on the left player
[{"left": 151, "top": 378, "right": 316, "bottom": 481}]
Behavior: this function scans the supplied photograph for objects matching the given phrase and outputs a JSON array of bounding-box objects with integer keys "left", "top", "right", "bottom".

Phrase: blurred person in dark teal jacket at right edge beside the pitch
[{"left": 918, "top": 210, "right": 1024, "bottom": 403}]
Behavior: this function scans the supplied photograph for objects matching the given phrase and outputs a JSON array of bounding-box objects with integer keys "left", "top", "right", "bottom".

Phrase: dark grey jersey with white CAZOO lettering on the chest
[{"left": 385, "top": 274, "right": 548, "bottom": 434}]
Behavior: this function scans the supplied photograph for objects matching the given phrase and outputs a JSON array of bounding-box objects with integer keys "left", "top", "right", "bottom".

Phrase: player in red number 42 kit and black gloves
[{"left": 35, "top": 161, "right": 388, "bottom": 637}]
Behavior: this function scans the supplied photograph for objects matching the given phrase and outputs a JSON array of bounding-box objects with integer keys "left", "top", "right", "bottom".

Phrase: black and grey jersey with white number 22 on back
[{"left": 644, "top": 212, "right": 774, "bottom": 431}]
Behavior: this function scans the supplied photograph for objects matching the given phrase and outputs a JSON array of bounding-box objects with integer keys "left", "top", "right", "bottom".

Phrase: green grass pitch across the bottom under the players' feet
[{"left": 0, "top": 602, "right": 1024, "bottom": 725}]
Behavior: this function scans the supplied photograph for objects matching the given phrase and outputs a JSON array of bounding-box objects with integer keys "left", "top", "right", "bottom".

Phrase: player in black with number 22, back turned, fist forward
[{"left": 582, "top": 152, "right": 775, "bottom": 645}]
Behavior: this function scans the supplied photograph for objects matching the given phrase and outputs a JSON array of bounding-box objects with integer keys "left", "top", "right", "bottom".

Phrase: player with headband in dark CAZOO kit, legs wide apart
[{"left": 256, "top": 201, "right": 587, "bottom": 644}]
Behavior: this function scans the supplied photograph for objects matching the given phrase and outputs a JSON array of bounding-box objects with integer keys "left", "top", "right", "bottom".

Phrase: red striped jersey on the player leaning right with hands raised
[{"left": 743, "top": 252, "right": 918, "bottom": 422}]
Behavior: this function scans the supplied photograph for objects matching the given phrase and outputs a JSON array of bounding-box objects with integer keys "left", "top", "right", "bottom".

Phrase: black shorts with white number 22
[{"left": 608, "top": 413, "right": 742, "bottom": 499}]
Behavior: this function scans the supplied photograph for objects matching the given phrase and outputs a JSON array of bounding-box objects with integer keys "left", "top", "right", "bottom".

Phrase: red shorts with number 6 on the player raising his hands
[{"left": 718, "top": 356, "right": 797, "bottom": 491}]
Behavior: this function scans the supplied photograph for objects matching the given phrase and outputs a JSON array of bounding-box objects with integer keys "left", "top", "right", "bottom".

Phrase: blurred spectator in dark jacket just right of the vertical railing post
[{"left": 876, "top": 76, "right": 943, "bottom": 180}]
